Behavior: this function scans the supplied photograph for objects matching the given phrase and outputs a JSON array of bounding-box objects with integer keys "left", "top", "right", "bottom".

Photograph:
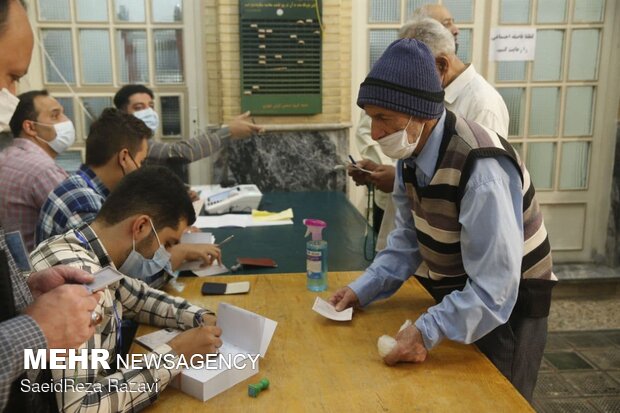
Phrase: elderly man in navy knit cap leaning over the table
[{"left": 330, "top": 39, "right": 557, "bottom": 400}]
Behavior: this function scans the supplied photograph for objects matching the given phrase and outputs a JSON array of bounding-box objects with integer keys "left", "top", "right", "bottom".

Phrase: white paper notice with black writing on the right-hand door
[{"left": 489, "top": 27, "right": 536, "bottom": 62}]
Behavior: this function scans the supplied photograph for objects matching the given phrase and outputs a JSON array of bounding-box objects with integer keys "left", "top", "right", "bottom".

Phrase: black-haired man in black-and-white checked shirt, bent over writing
[{"left": 30, "top": 167, "right": 222, "bottom": 412}]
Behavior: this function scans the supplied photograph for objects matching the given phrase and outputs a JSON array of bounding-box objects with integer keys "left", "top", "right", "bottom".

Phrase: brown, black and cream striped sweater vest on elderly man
[{"left": 402, "top": 111, "right": 557, "bottom": 317}]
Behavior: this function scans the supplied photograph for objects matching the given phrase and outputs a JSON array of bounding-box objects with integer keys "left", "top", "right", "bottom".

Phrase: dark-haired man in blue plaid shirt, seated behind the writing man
[{"left": 37, "top": 108, "right": 220, "bottom": 287}]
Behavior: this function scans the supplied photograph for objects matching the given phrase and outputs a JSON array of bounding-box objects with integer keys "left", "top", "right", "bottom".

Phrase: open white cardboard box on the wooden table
[{"left": 171, "top": 303, "right": 277, "bottom": 401}]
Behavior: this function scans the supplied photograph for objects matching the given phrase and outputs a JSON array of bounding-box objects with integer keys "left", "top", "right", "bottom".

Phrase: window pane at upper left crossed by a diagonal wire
[{"left": 41, "top": 29, "right": 75, "bottom": 83}]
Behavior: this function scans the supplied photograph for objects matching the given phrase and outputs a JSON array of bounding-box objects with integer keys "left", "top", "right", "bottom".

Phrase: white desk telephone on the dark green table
[{"left": 205, "top": 185, "right": 263, "bottom": 214}]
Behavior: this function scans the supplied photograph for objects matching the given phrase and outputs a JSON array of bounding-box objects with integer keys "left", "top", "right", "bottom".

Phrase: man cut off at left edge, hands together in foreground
[{"left": 0, "top": 0, "right": 98, "bottom": 413}]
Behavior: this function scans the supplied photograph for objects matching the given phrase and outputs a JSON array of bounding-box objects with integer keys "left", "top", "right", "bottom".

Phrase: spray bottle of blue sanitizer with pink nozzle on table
[{"left": 303, "top": 219, "right": 327, "bottom": 291}]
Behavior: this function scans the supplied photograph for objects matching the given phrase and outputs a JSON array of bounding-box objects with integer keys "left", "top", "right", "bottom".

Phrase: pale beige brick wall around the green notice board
[{"left": 202, "top": 0, "right": 352, "bottom": 125}]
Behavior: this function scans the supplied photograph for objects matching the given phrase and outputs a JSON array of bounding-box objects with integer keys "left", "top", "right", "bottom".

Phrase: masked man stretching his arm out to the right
[{"left": 114, "top": 84, "right": 262, "bottom": 163}]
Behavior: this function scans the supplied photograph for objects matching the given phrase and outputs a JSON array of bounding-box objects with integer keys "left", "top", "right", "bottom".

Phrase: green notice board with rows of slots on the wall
[{"left": 239, "top": 0, "right": 322, "bottom": 115}]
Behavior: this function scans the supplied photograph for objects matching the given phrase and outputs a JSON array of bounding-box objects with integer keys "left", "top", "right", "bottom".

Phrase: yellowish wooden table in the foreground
[{"left": 132, "top": 272, "right": 533, "bottom": 413}]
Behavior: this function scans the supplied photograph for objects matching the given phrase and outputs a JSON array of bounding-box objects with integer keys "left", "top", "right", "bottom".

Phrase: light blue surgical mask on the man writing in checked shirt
[{"left": 119, "top": 220, "right": 173, "bottom": 285}]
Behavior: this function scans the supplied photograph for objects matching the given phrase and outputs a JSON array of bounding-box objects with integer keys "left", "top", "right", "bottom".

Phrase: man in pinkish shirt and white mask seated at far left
[{"left": 0, "top": 90, "right": 75, "bottom": 251}]
